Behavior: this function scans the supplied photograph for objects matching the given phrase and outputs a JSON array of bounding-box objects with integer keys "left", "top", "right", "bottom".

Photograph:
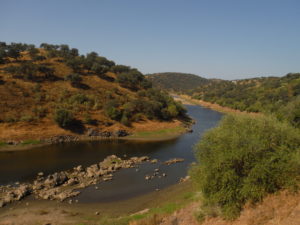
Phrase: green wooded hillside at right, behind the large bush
[{"left": 194, "top": 73, "right": 300, "bottom": 120}]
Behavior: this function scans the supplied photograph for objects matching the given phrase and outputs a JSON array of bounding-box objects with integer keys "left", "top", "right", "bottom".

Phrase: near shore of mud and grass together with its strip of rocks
[{"left": 0, "top": 155, "right": 195, "bottom": 225}]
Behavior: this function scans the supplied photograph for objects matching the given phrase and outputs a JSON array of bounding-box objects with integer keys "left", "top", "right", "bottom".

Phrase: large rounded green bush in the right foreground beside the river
[{"left": 191, "top": 115, "right": 300, "bottom": 219}]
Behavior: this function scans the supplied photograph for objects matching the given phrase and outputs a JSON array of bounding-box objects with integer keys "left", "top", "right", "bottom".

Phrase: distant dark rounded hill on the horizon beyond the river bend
[{"left": 146, "top": 72, "right": 211, "bottom": 93}]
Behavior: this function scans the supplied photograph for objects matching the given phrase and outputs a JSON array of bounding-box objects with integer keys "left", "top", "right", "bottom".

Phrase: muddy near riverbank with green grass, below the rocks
[{"left": 0, "top": 178, "right": 197, "bottom": 225}]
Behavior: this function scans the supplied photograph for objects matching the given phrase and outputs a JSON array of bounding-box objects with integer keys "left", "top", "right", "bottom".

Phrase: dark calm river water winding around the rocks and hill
[{"left": 0, "top": 105, "right": 222, "bottom": 202}]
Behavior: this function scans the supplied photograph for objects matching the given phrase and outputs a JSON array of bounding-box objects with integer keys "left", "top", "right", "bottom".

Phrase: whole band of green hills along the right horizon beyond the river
[{"left": 147, "top": 73, "right": 300, "bottom": 127}]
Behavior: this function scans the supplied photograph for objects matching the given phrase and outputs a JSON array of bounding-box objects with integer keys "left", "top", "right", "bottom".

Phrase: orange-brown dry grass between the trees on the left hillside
[{"left": 0, "top": 49, "right": 188, "bottom": 141}]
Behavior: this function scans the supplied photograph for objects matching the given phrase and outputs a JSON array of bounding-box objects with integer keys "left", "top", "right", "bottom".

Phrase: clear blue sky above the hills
[{"left": 0, "top": 0, "right": 300, "bottom": 79}]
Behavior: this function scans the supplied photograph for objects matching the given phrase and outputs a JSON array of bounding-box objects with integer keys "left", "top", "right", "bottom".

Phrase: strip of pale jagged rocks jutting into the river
[{"left": 0, "top": 155, "right": 183, "bottom": 207}]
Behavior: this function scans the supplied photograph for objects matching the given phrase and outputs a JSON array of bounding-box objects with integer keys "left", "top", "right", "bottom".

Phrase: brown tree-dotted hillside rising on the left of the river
[{"left": 0, "top": 42, "right": 185, "bottom": 141}]
